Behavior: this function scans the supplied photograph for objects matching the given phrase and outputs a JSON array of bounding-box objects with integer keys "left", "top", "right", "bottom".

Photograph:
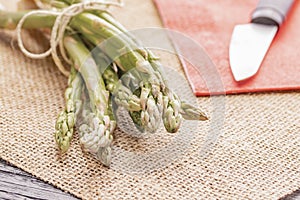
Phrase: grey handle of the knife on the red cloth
[{"left": 251, "top": 0, "right": 294, "bottom": 26}]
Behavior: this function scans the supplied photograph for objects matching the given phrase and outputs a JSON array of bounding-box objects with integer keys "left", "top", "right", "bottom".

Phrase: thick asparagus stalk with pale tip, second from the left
[{"left": 64, "top": 35, "right": 116, "bottom": 165}]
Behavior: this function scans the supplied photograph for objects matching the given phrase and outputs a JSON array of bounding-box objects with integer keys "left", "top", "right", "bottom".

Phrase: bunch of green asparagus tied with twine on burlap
[{"left": 0, "top": 0, "right": 207, "bottom": 166}]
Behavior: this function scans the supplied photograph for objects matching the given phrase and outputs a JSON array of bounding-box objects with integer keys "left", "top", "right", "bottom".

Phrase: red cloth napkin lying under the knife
[{"left": 154, "top": 0, "right": 300, "bottom": 96}]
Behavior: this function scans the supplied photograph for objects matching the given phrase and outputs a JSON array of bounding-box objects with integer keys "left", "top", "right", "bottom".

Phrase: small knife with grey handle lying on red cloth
[{"left": 229, "top": 0, "right": 294, "bottom": 81}]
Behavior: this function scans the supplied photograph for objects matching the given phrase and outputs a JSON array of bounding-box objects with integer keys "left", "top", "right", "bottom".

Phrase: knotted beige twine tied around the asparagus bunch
[{"left": 16, "top": 0, "right": 124, "bottom": 77}]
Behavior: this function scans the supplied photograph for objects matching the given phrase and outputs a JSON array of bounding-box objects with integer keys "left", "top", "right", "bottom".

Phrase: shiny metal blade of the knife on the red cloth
[{"left": 229, "top": 23, "right": 278, "bottom": 81}]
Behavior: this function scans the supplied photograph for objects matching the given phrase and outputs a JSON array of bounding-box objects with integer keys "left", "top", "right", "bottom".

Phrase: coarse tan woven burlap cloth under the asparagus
[{"left": 0, "top": 0, "right": 300, "bottom": 199}]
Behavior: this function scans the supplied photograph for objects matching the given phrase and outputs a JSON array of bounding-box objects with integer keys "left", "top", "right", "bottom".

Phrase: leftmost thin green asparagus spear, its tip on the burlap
[{"left": 55, "top": 67, "right": 83, "bottom": 153}]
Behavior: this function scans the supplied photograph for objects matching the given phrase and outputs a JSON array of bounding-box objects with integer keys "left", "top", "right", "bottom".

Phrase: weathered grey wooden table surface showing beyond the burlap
[{"left": 0, "top": 159, "right": 300, "bottom": 200}]
